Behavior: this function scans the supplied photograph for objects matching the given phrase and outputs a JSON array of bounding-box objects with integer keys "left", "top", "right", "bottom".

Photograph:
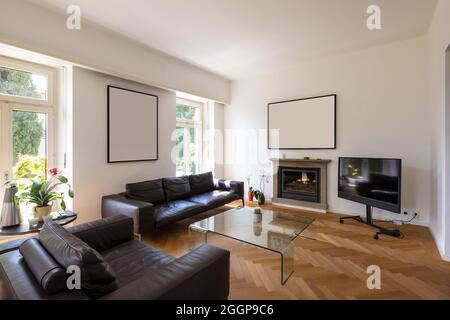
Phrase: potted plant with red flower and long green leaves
[{"left": 15, "top": 168, "right": 73, "bottom": 221}]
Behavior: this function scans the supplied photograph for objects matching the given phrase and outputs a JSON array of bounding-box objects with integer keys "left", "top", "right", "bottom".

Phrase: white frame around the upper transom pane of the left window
[{"left": 0, "top": 56, "right": 56, "bottom": 106}]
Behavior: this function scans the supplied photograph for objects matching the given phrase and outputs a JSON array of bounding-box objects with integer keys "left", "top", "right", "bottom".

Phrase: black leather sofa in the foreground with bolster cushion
[{"left": 0, "top": 215, "right": 230, "bottom": 300}]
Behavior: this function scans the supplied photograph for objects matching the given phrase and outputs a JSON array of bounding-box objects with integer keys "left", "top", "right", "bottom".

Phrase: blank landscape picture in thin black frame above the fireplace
[{"left": 267, "top": 94, "right": 337, "bottom": 150}]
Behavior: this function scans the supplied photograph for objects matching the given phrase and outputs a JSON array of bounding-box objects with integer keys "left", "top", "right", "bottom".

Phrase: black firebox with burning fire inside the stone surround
[{"left": 278, "top": 167, "right": 320, "bottom": 203}]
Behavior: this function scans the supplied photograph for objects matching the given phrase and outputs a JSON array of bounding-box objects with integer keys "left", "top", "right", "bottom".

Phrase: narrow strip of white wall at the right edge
[{"left": 427, "top": 0, "right": 450, "bottom": 260}]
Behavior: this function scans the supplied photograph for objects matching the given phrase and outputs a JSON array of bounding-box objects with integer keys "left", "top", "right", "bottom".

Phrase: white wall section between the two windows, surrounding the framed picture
[{"left": 73, "top": 67, "right": 176, "bottom": 223}]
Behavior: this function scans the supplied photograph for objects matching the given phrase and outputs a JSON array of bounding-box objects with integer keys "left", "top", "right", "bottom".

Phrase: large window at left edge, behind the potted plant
[{"left": 0, "top": 57, "right": 56, "bottom": 200}]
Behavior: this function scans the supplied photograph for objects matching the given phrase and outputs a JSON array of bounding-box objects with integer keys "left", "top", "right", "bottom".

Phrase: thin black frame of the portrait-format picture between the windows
[{"left": 107, "top": 85, "right": 159, "bottom": 164}]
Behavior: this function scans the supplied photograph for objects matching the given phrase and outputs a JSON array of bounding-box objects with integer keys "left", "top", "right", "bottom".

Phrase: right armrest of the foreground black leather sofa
[{"left": 101, "top": 245, "right": 230, "bottom": 300}]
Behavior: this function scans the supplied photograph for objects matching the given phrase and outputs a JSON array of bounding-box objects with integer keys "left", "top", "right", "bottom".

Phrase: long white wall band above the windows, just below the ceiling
[{"left": 0, "top": 0, "right": 230, "bottom": 102}]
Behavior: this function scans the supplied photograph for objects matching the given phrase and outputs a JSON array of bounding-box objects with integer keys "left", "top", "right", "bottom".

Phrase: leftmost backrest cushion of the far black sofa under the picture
[{"left": 126, "top": 179, "right": 166, "bottom": 204}]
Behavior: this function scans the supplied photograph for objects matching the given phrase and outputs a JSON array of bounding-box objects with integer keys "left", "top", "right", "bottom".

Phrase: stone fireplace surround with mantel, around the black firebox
[{"left": 270, "top": 159, "right": 331, "bottom": 213}]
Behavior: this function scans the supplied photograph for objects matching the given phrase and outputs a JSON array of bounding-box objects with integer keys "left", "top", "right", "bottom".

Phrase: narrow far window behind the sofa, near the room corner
[{"left": 175, "top": 99, "right": 203, "bottom": 176}]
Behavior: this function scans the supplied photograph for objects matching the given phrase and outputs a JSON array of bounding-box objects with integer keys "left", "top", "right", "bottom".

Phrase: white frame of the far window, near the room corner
[{"left": 175, "top": 97, "right": 204, "bottom": 175}]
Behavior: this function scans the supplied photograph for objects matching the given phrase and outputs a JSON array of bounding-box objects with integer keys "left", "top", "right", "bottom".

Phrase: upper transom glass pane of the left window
[{"left": 0, "top": 67, "right": 48, "bottom": 100}]
